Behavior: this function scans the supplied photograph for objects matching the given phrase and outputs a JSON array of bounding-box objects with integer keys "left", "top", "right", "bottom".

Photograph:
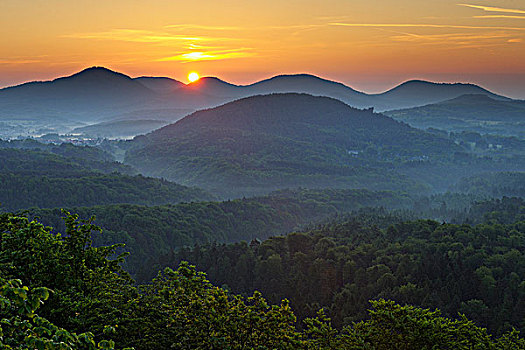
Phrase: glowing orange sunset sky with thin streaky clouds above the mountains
[{"left": 0, "top": 0, "right": 525, "bottom": 99}]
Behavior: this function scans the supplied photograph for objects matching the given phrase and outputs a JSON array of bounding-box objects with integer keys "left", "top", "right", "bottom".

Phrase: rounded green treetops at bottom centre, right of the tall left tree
[{"left": 117, "top": 263, "right": 301, "bottom": 350}]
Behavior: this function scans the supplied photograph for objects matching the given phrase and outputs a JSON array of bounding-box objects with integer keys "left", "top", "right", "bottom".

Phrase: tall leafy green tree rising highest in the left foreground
[{"left": 0, "top": 213, "right": 133, "bottom": 334}]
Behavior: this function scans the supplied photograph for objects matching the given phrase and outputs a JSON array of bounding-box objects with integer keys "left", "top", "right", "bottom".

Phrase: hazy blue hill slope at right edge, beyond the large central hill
[{"left": 386, "top": 94, "right": 525, "bottom": 137}]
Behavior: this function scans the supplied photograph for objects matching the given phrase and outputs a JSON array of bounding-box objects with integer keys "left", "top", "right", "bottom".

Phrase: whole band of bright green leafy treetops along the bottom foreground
[{"left": 0, "top": 213, "right": 525, "bottom": 350}]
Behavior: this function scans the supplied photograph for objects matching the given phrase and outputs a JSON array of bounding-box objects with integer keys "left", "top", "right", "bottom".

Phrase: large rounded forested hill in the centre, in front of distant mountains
[{"left": 125, "top": 94, "right": 459, "bottom": 196}]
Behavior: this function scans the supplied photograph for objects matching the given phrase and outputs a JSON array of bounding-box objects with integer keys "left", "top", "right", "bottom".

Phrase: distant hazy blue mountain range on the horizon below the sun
[{"left": 0, "top": 67, "right": 509, "bottom": 137}]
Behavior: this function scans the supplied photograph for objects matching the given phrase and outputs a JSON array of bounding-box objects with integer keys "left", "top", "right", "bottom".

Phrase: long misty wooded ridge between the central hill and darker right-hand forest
[{"left": 29, "top": 189, "right": 410, "bottom": 281}]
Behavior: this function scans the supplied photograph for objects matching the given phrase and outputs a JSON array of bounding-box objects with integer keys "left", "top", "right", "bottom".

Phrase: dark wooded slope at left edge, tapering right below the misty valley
[{"left": 0, "top": 146, "right": 215, "bottom": 211}]
